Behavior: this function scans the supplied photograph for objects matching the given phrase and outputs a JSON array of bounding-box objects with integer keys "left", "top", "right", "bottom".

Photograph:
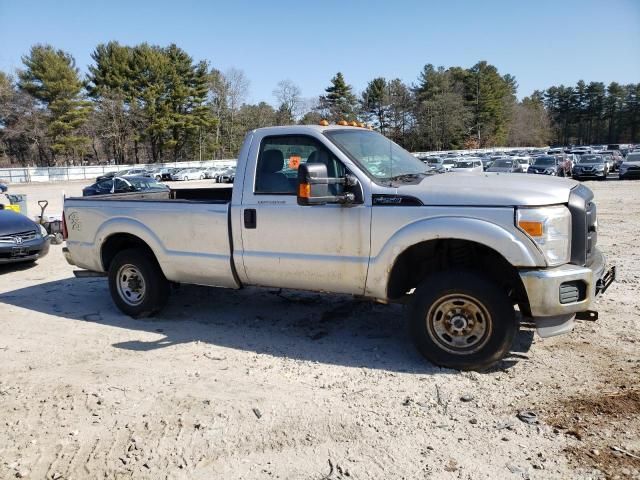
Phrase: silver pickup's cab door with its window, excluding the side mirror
[{"left": 241, "top": 135, "right": 371, "bottom": 294}]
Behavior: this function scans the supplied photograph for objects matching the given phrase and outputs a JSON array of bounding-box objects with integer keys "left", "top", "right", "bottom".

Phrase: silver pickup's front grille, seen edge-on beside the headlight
[{"left": 569, "top": 185, "right": 598, "bottom": 266}]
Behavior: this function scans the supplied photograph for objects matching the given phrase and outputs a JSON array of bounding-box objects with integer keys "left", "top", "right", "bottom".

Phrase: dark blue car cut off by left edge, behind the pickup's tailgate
[{"left": 0, "top": 205, "right": 51, "bottom": 264}]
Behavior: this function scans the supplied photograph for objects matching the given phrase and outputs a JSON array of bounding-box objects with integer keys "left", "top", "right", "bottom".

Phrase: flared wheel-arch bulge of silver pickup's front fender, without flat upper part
[{"left": 365, "top": 216, "right": 546, "bottom": 299}]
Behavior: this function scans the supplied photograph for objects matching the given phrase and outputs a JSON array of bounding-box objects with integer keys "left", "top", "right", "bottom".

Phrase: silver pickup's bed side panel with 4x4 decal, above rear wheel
[{"left": 65, "top": 199, "right": 238, "bottom": 288}]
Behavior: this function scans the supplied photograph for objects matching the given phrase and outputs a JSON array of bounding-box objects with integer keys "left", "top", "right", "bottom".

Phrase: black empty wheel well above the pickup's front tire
[{"left": 387, "top": 239, "right": 530, "bottom": 316}]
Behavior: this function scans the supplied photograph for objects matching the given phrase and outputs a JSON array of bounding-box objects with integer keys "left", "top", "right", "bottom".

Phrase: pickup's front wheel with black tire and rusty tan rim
[{"left": 411, "top": 271, "right": 519, "bottom": 370}]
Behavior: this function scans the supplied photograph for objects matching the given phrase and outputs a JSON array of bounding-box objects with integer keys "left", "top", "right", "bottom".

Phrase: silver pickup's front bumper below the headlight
[{"left": 520, "top": 248, "right": 616, "bottom": 336}]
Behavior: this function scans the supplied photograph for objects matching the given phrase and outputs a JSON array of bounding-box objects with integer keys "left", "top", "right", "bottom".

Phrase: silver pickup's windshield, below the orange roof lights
[{"left": 325, "top": 129, "right": 426, "bottom": 180}]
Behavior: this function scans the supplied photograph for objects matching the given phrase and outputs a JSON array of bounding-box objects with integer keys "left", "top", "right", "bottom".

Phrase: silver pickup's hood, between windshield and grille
[{"left": 398, "top": 173, "right": 578, "bottom": 206}]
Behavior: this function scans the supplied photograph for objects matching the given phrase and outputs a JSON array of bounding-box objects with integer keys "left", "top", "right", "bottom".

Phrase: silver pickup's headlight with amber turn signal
[{"left": 516, "top": 205, "right": 571, "bottom": 266}]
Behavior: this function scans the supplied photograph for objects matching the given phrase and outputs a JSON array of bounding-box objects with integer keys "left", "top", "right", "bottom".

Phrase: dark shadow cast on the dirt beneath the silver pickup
[{"left": 0, "top": 278, "right": 533, "bottom": 374}]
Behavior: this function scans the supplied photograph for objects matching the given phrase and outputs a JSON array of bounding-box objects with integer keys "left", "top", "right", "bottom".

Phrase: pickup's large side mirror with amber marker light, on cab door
[{"left": 297, "top": 163, "right": 356, "bottom": 206}]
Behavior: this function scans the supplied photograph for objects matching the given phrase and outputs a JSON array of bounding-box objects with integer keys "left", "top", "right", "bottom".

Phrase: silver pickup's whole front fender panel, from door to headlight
[{"left": 365, "top": 206, "right": 545, "bottom": 298}]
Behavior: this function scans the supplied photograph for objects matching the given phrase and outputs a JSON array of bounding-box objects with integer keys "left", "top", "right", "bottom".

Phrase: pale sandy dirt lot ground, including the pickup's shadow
[{"left": 0, "top": 181, "right": 640, "bottom": 480}]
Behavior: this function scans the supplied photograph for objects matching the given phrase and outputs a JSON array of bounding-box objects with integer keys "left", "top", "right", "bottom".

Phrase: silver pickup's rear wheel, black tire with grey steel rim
[{"left": 109, "top": 248, "right": 169, "bottom": 318}]
